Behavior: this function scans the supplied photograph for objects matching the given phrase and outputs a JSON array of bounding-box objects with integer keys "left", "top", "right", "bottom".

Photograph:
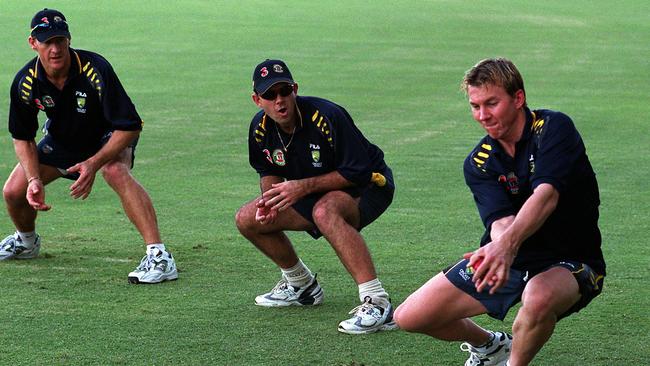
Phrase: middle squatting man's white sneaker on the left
[{"left": 255, "top": 275, "right": 324, "bottom": 307}]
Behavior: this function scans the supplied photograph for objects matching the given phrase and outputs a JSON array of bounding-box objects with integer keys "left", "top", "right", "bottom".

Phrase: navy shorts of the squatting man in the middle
[{"left": 291, "top": 167, "right": 395, "bottom": 239}]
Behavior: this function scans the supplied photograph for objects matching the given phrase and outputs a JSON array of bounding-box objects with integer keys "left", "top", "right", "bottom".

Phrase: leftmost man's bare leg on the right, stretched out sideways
[{"left": 102, "top": 148, "right": 162, "bottom": 244}]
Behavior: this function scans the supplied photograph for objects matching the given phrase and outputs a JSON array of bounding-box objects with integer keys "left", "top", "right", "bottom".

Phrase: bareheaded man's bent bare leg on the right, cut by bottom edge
[{"left": 510, "top": 267, "right": 580, "bottom": 366}]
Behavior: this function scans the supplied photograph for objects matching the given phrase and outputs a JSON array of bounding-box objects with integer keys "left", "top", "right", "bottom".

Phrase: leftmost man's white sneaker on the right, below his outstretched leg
[{"left": 129, "top": 248, "right": 178, "bottom": 284}]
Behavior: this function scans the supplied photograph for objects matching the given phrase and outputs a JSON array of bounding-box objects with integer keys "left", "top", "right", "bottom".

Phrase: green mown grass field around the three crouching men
[{"left": 0, "top": 0, "right": 650, "bottom": 366}]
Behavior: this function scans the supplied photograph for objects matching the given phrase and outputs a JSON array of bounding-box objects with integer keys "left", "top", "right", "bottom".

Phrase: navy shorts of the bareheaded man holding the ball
[{"left": 443, "top": 259, "right": 604, "bottom": 320}]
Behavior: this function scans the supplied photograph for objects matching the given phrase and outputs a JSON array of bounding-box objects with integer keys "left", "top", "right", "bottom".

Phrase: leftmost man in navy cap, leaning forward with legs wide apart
[{"left": 0, "top": 9, "right": 178, "bottom": 283}]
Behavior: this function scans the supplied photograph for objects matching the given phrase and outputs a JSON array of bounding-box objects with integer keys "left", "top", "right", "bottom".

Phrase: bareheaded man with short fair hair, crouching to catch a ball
[{"left": 395, "top": 58, "right": 605, "bottom": 366}]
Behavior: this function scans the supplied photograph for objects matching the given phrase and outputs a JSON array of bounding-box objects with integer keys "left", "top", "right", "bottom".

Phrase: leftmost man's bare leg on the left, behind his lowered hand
[{"left": 2, "top": 164, "right": 61, "bottom": 232}]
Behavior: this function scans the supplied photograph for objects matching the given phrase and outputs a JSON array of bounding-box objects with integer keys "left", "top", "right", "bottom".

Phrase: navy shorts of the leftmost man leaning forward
[{"left": 37, "top": 132, "right": 138, "bottom": 180}]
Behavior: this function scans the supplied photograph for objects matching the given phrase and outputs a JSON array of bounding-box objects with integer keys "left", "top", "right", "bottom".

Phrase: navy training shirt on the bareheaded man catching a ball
[{"left": 464, "top": 108, "right": 605, "bottom": 275}]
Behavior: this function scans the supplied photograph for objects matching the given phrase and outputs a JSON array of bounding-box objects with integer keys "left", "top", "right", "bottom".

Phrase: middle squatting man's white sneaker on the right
[{"left": 339, "top": 296, "right": 398, "bottom": 334}]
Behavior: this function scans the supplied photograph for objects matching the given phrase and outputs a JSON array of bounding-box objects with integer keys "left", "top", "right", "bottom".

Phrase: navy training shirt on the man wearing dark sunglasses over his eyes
[{"left": 248, "top": 96, "right": 386, "bottom": 186}]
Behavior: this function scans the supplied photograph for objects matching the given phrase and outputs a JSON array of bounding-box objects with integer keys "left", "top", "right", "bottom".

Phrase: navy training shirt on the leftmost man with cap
[{"left": 9, "top": 48, "right": 142, "bottom": 153}]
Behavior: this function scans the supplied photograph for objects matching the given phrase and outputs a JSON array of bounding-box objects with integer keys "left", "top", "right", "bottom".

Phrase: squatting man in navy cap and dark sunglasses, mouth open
[{"left": 236, "top": 60, "right": 396, "bottom": 334}]
